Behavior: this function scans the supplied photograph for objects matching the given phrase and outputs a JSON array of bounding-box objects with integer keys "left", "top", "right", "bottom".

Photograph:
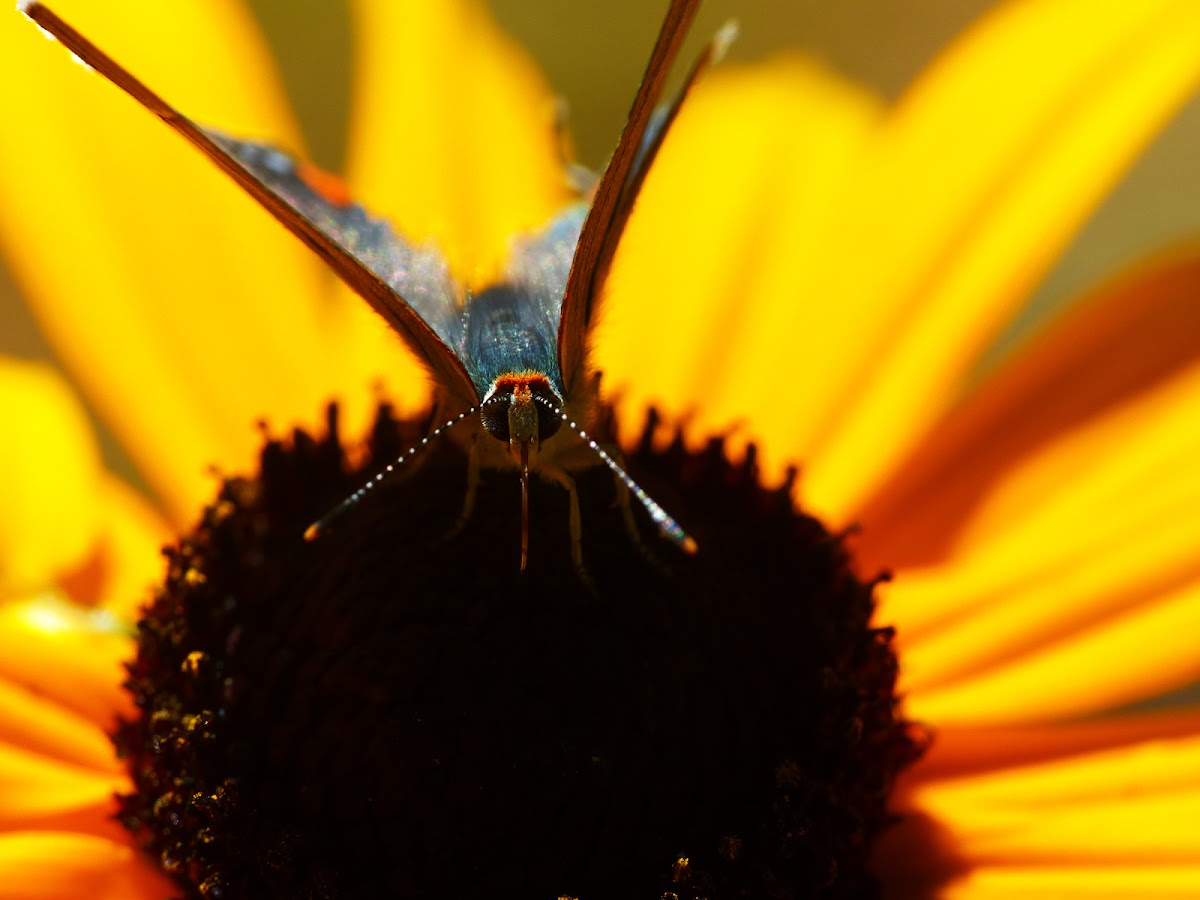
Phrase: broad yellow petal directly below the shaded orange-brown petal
[{"left": 881, "top": 355, "right": 1200, "bottom": 703}]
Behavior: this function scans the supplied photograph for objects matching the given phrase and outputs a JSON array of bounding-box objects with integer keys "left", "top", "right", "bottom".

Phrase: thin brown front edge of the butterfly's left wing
[{"left": 20, "top": 2, "right": 478, "bottom": 408}]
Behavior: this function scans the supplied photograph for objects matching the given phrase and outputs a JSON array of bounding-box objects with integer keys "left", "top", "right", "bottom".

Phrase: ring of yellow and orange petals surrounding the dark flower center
[{"left": 0, "top": 0, "right": 1200, "bottom": 898}]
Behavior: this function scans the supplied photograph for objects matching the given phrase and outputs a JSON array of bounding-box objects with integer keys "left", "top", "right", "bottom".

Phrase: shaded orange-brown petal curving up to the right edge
[{"left": 856, "top": 245, "right": 1200, "bottom": 568}]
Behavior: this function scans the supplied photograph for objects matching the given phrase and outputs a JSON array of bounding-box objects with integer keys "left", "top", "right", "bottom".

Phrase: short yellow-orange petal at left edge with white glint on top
[{"left": 0, "top": 596, "right": 133, "bottom": 728}]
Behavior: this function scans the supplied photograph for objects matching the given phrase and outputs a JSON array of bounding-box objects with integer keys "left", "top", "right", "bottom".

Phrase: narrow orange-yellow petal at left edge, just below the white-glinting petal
[{"left": 0, "top": 679, "right": 120, "bottom": 772}]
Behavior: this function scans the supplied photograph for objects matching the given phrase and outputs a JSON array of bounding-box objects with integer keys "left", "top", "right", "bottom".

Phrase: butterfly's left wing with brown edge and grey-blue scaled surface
[{"left": 23, "top": 2, "right": 476, "bottom": 408}]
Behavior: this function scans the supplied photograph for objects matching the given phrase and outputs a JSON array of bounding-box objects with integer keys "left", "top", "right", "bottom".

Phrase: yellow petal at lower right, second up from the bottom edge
[{"left": 912, "top": 737, "right": 1200, "bottom": 865}]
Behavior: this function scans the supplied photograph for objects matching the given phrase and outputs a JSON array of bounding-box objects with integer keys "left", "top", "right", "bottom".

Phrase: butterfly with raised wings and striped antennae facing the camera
[{"left": 20, "top": 0, "right": 733, "bottom": 570}]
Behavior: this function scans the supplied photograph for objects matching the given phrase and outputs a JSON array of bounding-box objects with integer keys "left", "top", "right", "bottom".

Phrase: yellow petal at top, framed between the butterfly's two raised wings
[{"left": 349, "top": 0, "right": 568, "bottom": 283}]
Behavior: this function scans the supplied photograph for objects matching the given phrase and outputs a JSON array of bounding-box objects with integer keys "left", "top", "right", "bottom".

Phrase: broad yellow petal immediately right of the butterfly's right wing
[{"left": 594, "top": 56, "right": 880, "bottom": 468}]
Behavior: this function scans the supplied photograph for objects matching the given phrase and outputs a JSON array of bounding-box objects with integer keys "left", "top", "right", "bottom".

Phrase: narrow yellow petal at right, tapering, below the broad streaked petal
[{"left": 901, "top": 580, "right": 1200, "bottom": 724}]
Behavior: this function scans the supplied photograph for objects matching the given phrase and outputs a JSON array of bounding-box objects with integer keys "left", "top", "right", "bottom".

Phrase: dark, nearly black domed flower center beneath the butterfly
[{"left": 116, "top": 408, "right": 918, "bottom": 900}]
